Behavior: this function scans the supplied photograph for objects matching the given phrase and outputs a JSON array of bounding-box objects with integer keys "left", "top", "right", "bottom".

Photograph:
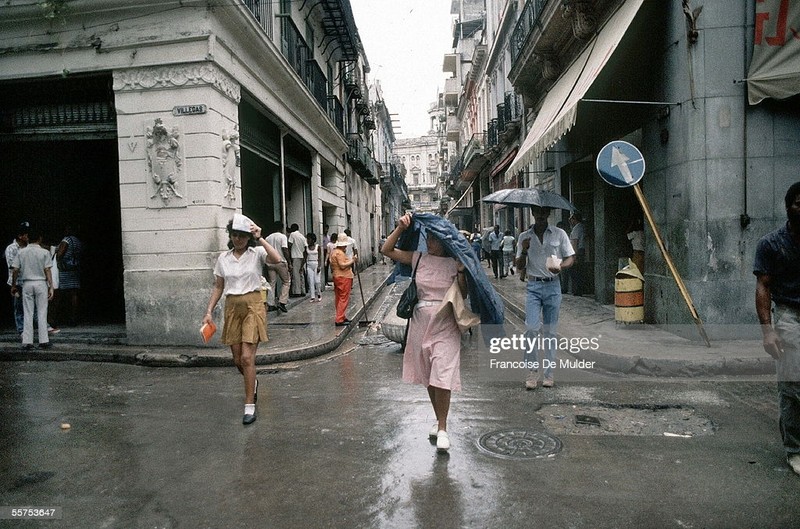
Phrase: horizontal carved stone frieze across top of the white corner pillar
[{"left": 114, "top": 63, "right": 242, "bottom": 103}]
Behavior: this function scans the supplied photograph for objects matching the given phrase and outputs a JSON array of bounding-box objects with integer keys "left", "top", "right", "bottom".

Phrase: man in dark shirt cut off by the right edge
[{"left": 753, "top": 182, "right": 800, "bottom": 475}]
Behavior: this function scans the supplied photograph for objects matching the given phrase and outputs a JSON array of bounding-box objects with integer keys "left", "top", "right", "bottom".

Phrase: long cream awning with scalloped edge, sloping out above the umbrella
[{"left": 508, "top": 0, "right": 644, "bottom": 177}]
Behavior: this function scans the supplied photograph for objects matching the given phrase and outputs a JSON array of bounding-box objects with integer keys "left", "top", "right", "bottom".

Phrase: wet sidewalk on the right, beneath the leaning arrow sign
[{"left": 488, "top": 262, "right": 775, "bottom": 377}]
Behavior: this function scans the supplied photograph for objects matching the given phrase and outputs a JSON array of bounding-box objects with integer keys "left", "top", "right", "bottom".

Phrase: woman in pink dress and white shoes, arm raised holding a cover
[{"left": 381, "top": 214, "right": 467, "bottom": 452}]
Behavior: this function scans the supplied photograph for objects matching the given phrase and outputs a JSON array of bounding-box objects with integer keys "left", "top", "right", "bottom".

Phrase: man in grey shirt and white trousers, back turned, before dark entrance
[{"left": 11, "top": 230, "right": 53, "bottom": 349}]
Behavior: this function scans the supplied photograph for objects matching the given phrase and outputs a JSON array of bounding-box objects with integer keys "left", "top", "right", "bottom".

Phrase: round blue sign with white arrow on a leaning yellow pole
[{"left": 597, "top": 141, "right": 711, "bottom": 347}]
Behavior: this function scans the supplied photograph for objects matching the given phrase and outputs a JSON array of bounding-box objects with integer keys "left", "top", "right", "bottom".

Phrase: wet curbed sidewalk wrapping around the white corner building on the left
[{"left": 0, "top": 264, "right": 392, "bottom": 367}]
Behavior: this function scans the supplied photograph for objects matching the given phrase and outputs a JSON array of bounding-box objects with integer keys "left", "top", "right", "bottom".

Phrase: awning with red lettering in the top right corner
[{"left": 747, "top": 0, "right": 800, "bottom": 105}]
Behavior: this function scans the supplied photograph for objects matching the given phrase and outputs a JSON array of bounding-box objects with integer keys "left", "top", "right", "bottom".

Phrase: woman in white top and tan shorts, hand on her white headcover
[{"left": 203, "top": 219, "right": 281, "bottom": 424}]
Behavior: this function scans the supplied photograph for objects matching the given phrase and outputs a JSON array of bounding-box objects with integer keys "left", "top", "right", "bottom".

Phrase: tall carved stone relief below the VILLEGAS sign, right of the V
[{"left": 145, "top": 118, "right": 186, "bottom": 208}]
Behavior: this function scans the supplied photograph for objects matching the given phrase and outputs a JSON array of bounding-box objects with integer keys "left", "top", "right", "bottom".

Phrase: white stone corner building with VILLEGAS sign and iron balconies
[{"left": 0, "top": 0, "right": 380, "bottom": 345}]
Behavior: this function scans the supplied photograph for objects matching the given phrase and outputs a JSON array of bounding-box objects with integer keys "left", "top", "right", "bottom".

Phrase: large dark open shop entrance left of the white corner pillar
[{"left": 0, "top": 75, "right": 125, "bottom": 329}]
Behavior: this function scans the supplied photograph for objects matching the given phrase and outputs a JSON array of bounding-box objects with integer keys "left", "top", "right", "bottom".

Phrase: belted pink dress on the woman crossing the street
[{"left": 403, "top": 252, "right": 461, "bottom": 391}]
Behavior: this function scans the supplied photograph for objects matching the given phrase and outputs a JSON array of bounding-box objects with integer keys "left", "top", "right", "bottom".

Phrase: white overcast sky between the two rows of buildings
[{"left": 350, "top": 0, "right": 453, "bottom": 138}]
